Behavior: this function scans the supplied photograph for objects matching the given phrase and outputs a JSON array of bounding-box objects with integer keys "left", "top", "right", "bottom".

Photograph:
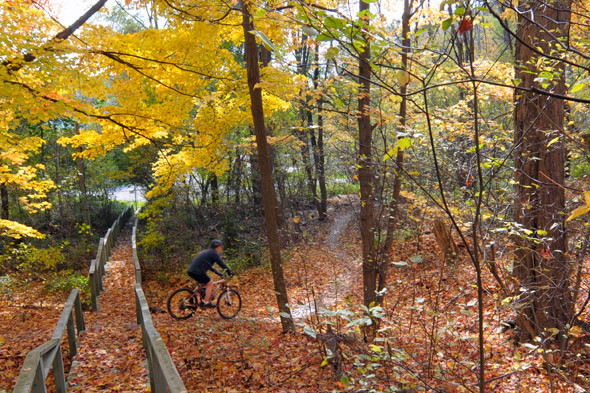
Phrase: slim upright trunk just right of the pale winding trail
[{"left": 357, "top": 1, "right": 378, "bottom": 340}]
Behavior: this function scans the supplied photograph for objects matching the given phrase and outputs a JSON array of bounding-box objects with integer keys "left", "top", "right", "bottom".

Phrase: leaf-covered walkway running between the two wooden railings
[{"left": 68, "top": 220, "right": 149, "bottom": 392}]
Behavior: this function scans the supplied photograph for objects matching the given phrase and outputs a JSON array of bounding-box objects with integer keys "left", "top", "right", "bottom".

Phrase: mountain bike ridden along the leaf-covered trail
[{"left": 167, "top": 279, "right": 242, "bottom": 320}]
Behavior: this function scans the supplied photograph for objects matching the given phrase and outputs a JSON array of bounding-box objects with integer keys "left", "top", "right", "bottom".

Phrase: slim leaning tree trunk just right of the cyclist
[{"left": 241, "top": 0, "right": 295, "bottom": 332}]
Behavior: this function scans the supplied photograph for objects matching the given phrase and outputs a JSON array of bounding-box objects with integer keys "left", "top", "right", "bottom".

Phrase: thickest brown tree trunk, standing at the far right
[{"left": 514, "top": 0, "right": 573, "bottom": 341}]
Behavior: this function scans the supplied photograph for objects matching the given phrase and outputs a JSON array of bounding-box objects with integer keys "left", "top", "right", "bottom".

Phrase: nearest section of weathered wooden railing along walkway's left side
[{"left": 13, "top": 288, "right": 85, "bottom": 393}]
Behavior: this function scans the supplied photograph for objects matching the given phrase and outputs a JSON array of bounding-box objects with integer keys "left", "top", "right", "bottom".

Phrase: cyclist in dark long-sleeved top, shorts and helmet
[{"left": 187, "top": 239, "right": 233, "bottom": 307}]
